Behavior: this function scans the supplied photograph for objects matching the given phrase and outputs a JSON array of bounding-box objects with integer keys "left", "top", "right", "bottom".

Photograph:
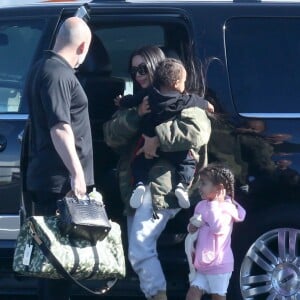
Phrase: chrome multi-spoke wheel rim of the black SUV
[{"left": 240, "top": 228, "right": 300, "bottom": 300}]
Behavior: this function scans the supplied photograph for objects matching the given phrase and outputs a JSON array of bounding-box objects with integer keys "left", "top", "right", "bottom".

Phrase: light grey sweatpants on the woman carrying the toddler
[{"left": 127, "top": 187, "right": 180, "bottom": 298}]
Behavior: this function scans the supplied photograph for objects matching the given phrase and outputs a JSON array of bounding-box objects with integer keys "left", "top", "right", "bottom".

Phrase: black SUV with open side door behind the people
[{"left": 0, "top": 0, "right": 300, "bottom": 300}]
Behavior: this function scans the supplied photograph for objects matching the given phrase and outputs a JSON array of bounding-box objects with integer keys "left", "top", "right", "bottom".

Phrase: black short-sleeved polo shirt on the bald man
[{"left": 24, "top": 51, "right": 94, "bottom": 193}]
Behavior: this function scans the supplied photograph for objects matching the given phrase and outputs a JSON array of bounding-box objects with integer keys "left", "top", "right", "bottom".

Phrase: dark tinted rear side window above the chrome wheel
[{"left": 225, "top": 18, "right": 300, "bottom": 113}]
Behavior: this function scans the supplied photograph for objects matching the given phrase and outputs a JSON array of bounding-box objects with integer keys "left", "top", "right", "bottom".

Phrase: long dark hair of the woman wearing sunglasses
[{"left": 129, "top": 45, "right": 165, "bottom": 83}]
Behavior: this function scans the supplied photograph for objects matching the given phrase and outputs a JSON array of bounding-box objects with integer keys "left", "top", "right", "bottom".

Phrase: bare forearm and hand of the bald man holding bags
[{"left": 50, "top": 122, "right": 86, "bottom": 197}]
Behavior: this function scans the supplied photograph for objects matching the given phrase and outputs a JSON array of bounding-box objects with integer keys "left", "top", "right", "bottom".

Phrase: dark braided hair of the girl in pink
[{"left": 200, "top": 164, "right": 235, "bottom": 200}]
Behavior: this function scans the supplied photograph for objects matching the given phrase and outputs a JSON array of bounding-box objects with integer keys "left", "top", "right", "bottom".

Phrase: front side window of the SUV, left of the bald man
[{"left": 0, "top": 20, "right": 44, "bottom": 113}]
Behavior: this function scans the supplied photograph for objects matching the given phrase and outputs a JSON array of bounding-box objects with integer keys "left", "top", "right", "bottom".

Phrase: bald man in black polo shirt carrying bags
[{"left": 24, "top": 17, "right": 94, "bottom": 300}]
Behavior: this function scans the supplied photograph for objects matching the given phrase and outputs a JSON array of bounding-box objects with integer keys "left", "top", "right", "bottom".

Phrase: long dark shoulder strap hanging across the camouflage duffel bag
[{"left": 29, "top": 221, "right": 118, "bottom": 296}]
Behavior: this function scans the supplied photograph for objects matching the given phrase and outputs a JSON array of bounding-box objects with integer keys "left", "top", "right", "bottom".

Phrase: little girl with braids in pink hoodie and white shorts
[{"left": 186, "top": 165, "right": 246, "bottom": 300}]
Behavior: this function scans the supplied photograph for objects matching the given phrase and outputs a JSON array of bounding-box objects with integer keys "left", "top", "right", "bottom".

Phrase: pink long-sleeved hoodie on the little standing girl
[{"left": 194, "top": 198, "right": 246, "bottom": 274}]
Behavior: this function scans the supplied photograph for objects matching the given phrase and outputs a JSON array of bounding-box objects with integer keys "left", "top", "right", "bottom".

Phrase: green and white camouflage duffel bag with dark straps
[{"left": 13, "top": 216, "right": 125, "bottom": 294}]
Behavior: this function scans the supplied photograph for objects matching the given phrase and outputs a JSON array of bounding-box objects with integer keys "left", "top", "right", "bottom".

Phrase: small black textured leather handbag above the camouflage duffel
[{"left": 57, "top": 190, "right": 111, "bottom": 243}]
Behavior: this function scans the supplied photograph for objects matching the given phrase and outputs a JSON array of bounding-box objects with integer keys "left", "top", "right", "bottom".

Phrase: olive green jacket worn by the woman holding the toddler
[{"left": 103, "top": 107, "right": 211, "bottom": 214}]
